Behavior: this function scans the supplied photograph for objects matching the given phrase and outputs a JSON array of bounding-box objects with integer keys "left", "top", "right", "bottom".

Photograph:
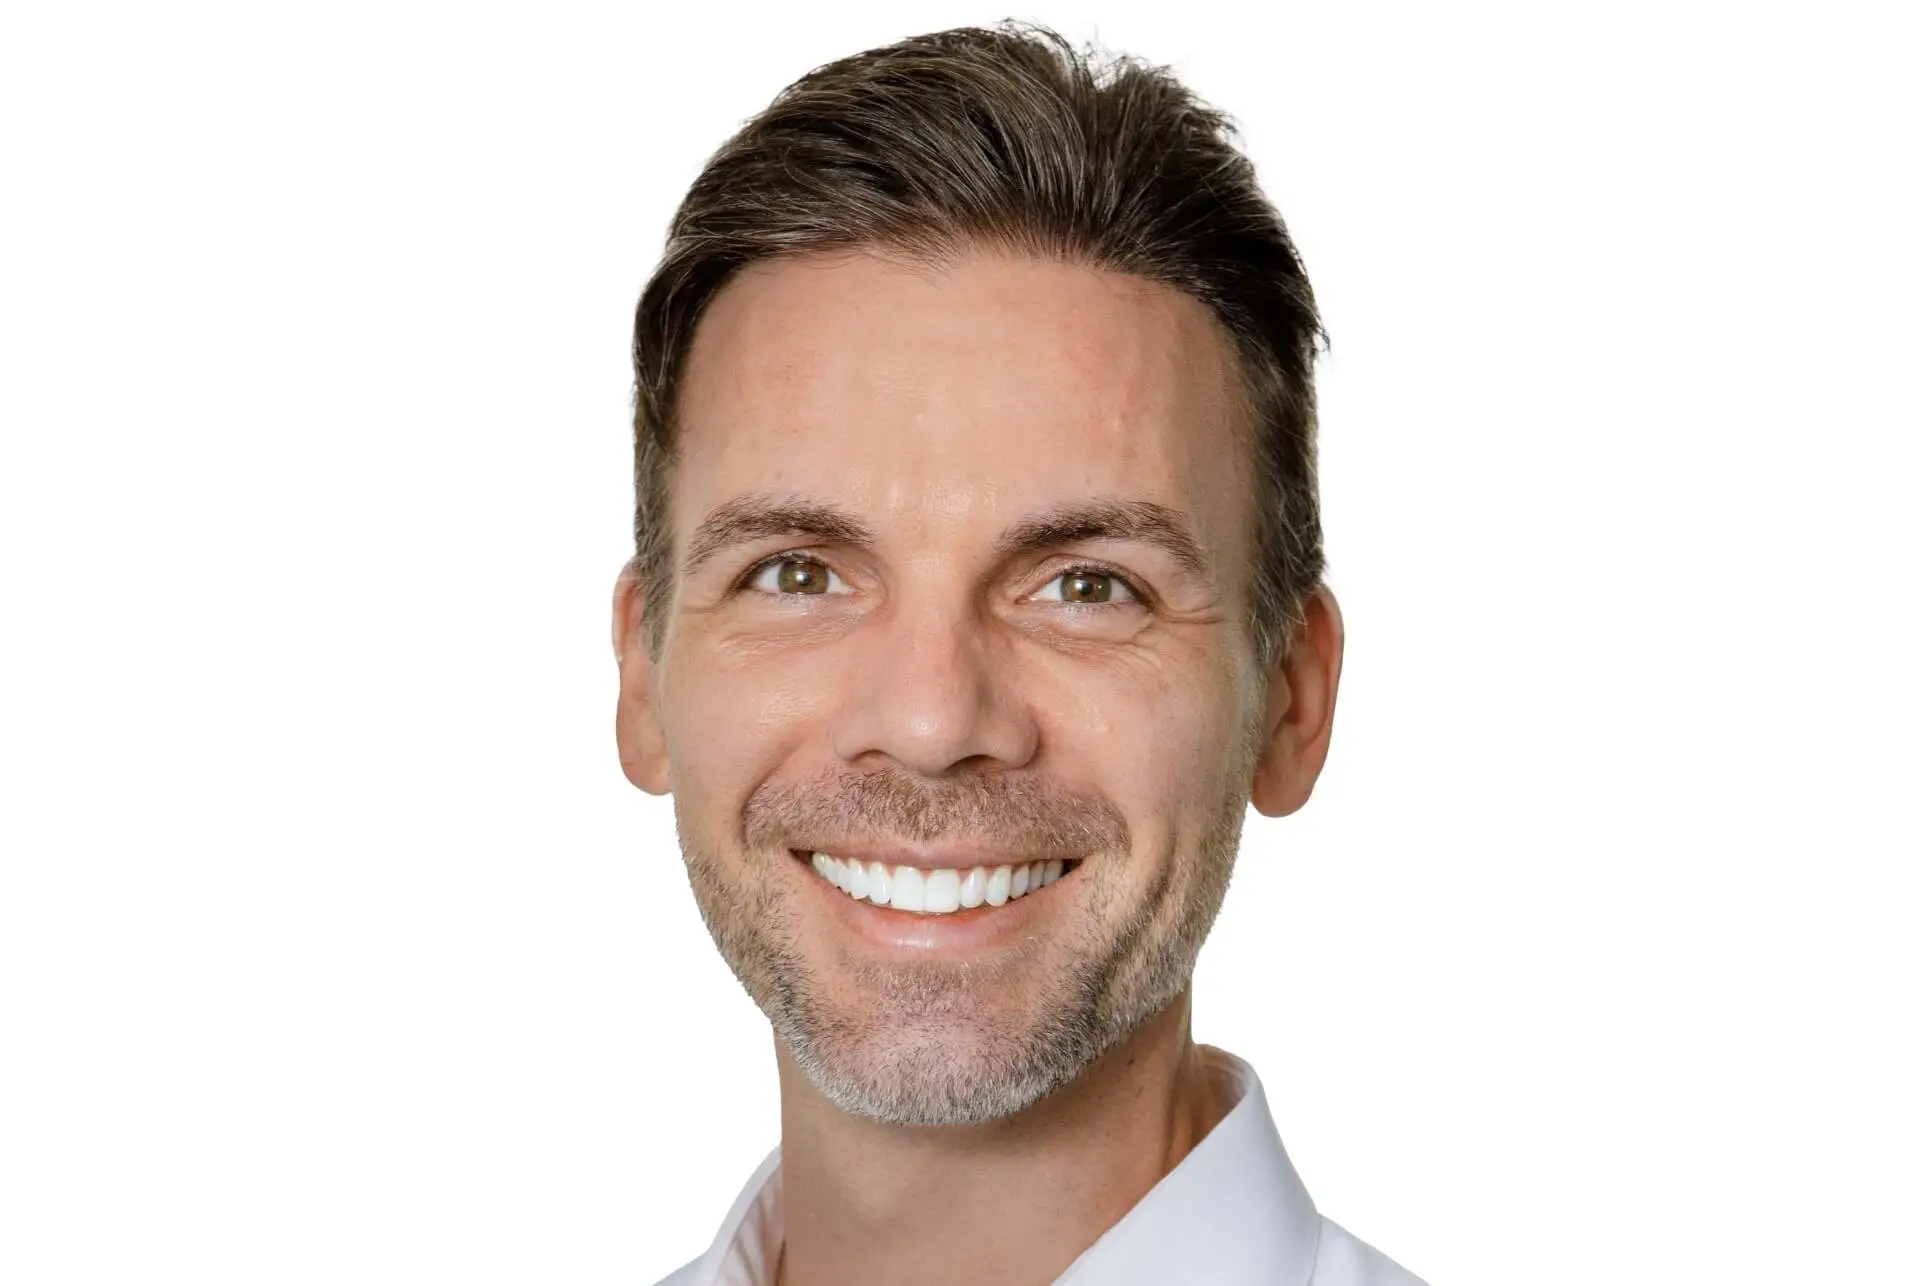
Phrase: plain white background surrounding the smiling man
[{"left": 0, "top": 0, "right": 1920, "bottom": 1286}]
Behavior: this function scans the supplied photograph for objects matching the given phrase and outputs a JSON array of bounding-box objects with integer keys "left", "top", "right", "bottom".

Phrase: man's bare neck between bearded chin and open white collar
[{"left": 780, "top": 992, "right": 1231, "bottom": 1286}]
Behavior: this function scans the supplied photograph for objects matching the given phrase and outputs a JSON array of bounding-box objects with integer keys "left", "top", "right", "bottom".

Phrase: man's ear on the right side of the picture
[{"left": 1252, "top": 585, "right": 1346, "bottom": 818}]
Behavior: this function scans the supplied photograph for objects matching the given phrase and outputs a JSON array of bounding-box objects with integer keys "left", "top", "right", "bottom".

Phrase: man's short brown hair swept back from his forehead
[{"left": 632, "top": 21, "right": 1325, "bottom": 660}]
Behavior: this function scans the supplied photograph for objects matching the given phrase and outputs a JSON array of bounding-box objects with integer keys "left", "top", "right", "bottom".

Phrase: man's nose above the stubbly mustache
[{"left": 833, "top": 591, "right": 1039, "bottom": 777}]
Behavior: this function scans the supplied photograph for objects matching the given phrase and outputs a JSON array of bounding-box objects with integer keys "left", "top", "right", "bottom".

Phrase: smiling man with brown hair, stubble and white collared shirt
[{"left": 614, "top": 25, "right": 1415, "bottom": 1286}]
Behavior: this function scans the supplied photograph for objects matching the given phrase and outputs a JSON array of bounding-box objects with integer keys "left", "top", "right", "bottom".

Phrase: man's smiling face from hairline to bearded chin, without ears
[{"left": 622, "top": 253, "right": 1263, "bottom": 1123}]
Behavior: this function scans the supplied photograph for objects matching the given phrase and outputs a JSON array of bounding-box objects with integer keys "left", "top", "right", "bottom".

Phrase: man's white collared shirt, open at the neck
[{"left": 659, "top": 1054, "right": 1423, "bottom": 1286}]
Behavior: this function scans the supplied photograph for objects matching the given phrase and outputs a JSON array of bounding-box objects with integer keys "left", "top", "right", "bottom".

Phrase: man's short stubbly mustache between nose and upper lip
[{"left": 741, "top": 770, "right": 1131, "bottom": 858}]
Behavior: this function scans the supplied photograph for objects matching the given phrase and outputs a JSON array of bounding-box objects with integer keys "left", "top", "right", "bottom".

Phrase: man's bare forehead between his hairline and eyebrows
[{"left": 674, "top": 253, "right": 1246, "bottom": 543}]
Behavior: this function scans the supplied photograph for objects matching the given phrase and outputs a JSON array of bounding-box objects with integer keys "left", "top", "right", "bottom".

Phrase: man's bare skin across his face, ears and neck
[{"left": 614, "top": 251, "right": 1344, "bottom": 1286}]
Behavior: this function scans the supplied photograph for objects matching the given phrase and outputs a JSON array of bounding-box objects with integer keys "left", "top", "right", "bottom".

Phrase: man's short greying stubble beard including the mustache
[{"left": 678, "top": 772, "right": 1246, "bottom": 1125}]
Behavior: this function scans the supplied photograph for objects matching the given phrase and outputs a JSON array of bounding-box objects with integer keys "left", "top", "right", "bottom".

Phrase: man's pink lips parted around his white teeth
[{"left": 787, "top": 848, "right": 1069, "bottom": 956}]
